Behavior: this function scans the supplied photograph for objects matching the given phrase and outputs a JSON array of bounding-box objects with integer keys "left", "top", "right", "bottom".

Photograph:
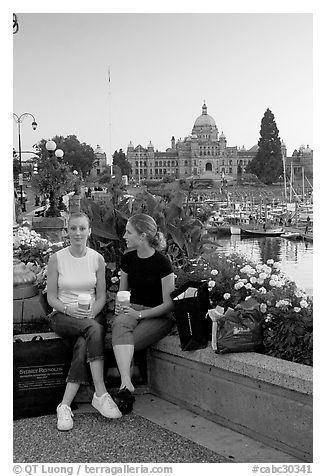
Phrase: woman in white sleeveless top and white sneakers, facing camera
[{"left": 47, "top": 213, "right": 121, "bottom": 430}]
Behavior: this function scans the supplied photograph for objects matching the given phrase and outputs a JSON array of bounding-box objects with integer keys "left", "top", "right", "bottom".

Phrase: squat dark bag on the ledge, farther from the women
[{"left": 208, "top": 298, "right": 263, "bottom": 354}]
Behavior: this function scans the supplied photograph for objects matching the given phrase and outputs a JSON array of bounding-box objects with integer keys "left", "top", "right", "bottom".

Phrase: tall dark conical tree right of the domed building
[{"left": 246, "top": 108, "right": 283, "bottom": 185}]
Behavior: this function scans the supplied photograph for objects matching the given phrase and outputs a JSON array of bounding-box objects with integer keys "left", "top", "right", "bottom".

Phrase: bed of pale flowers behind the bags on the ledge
[{"left": 175, "top": 253, "right": 313, "bottom": 365}]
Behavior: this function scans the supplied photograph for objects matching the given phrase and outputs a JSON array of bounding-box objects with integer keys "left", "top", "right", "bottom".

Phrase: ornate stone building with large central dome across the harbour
[{"left": 127, "top": 102, "right": 256, "bottom": 181}]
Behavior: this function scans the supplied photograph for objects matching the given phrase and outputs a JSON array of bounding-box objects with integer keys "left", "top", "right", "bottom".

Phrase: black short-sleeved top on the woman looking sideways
[{"left": 121, "top": 250, "right": 173, "bottom": 307}]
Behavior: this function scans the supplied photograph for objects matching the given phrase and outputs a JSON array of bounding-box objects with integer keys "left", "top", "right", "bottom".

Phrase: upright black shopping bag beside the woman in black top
[{"left": 171, "top": 281, "right": 210, "bottom": 350}]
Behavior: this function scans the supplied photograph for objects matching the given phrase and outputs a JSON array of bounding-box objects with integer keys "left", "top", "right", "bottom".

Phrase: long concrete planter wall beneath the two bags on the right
[{"left": 148, "top": 336, "right": 313, "bottom": 462}]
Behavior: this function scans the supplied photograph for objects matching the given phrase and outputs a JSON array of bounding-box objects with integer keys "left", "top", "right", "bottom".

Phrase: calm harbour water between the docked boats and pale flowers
[{"left": 209, "top": 234, "right": 313, "bottom": 295}]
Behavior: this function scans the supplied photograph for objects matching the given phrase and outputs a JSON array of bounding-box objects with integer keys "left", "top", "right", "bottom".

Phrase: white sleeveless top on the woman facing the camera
[{"left": 56, "top": 247, "right": 99, "bottom": 304}]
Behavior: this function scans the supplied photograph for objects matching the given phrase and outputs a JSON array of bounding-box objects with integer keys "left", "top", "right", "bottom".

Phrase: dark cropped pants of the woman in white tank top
[{"left": 50, "top": 312, "right": 105, "bottom": 385}]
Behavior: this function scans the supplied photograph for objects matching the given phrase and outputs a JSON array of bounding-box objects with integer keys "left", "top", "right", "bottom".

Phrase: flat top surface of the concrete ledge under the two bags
[{"left": 152, "top": 335, "right": 313, "bottom": 395}]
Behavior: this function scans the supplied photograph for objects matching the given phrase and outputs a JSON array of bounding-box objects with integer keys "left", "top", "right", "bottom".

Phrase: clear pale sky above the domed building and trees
[{"left": 13, "top": 9, "right": 313, "bottom": 162}]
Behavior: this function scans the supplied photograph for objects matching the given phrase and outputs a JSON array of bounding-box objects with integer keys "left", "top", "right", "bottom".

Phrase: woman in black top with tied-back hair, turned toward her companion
[{"left": 112, "top": 213, "right": 174, "bottom": 408}]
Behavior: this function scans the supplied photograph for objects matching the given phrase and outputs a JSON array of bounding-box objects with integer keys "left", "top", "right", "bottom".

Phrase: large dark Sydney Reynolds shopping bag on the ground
[{"left": 13, "top": 332, "right": 72, "bottom": 419}]
